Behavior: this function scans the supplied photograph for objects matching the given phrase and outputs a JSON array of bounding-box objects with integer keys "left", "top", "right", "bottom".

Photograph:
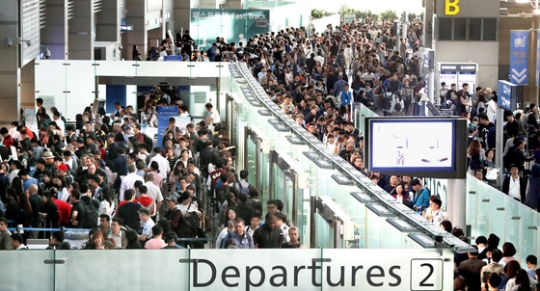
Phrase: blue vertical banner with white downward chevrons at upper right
[{"left": 510, "top": 31, "right": 530, "bottom": 85}]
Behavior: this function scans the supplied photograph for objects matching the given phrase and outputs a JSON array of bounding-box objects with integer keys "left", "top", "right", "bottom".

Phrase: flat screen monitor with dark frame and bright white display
[{"left": 365, "top": 117, "right": 466, "bottom": 178}]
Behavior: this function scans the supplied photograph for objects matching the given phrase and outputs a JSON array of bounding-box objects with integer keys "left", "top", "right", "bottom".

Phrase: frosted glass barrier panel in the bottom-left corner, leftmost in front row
[{"left": 0, "top": 249, "right": 54, "bottom": 291}]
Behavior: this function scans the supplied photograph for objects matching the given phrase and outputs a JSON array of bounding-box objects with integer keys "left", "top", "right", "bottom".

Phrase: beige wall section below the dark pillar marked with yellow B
[{"left": 434, "top": 41, "right": 499, "bottom": 88}]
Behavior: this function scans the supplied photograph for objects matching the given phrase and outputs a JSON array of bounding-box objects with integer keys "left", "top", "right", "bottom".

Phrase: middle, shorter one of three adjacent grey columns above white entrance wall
[{"left": 96, "top": 0, "right": 120, "bottom": 42}]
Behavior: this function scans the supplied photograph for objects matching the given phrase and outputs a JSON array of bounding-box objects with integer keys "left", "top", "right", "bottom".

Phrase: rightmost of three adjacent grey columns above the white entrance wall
[{"left": 122, "top": 0, "right": 148, "bottom": 60}]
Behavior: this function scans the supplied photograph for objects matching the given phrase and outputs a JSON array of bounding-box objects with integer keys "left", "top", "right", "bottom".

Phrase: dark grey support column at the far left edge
[{"left": 0, "top": 0, "right": 21, "bottom": 126}]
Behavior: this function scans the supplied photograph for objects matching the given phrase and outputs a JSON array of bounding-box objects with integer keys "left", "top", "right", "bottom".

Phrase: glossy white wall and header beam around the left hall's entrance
[{"left": 34, "top": 60, "right": 230, "bottom": 121}]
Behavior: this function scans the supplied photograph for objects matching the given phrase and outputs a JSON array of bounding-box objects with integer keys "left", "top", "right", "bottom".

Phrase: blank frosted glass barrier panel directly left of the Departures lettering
[{"left": 54, "top": 249, "right": 191, "bottom": 290}]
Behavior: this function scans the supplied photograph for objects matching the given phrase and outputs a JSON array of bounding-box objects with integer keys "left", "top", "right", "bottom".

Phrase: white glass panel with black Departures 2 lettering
[{"left": 180, "top": 249, "right": 453, "bottom": 291}]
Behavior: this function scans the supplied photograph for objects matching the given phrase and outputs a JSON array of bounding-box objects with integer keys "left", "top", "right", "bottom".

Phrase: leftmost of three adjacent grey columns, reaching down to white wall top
[{"left": 68, "top": 0, "right": 93, "bottom": 60}]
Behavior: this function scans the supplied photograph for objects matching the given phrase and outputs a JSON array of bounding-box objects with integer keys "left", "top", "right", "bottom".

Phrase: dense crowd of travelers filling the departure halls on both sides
[{"left": 0, "top": 15, "right": 540, "bottom": 290}]
